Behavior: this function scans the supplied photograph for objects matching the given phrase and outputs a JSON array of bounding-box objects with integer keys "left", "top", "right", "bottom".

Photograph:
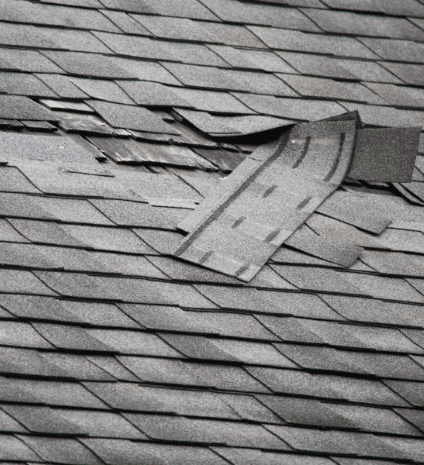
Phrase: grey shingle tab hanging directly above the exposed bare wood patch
[{"left": 89, "top": 100, "right": 181, "bottom": 134}]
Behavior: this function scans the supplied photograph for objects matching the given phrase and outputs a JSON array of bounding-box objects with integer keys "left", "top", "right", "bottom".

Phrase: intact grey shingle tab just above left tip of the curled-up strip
[{"left": 118, "top": 81, "right": 189, "bottom": 107}]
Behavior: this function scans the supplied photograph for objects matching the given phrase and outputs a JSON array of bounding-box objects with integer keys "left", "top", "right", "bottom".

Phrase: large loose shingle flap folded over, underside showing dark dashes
[{"left": 175, "top": 120, "right": 356, "bottom": 281}]
